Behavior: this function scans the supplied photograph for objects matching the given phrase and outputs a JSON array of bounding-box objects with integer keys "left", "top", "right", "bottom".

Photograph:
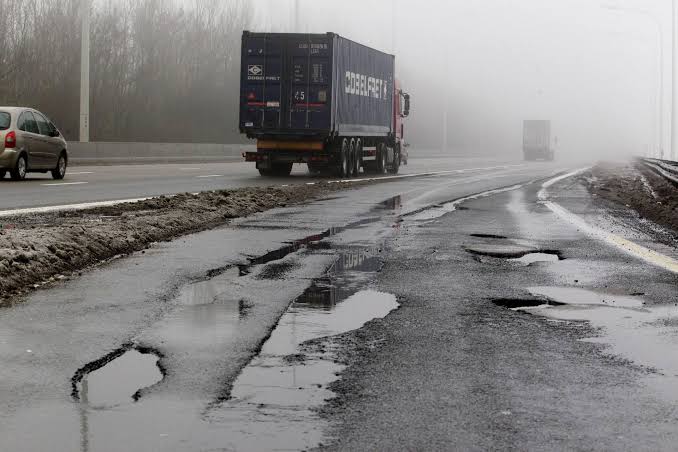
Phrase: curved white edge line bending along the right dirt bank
[{"left": 538, "top": 168, "right": 678, "bottom": 273}]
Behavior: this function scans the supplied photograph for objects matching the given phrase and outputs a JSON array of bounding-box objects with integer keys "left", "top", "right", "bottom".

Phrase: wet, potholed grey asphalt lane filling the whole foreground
[{"left": 0, "top": 158, "right": 676, "bottom": 451}]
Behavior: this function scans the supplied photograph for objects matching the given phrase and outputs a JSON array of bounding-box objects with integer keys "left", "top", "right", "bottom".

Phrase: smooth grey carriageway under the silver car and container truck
[{"left": 0, "top": 158, "right": 539, "bottom": 212}]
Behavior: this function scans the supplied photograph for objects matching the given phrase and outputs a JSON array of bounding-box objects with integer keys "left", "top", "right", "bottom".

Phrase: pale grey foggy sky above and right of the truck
[{"left": 252, "top": 0, "right": 671, "bottom": 160}]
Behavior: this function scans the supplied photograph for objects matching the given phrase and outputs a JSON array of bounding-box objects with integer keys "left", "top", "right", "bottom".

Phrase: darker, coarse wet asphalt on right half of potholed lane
[{"left": 323, "top": 175, "right": 678, "bottom": 450}]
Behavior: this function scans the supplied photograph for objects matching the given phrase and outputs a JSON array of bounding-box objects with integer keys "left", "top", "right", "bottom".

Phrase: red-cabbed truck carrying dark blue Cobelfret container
[{"left": 239, "top": 31, "right": 410, "bottom": 178}]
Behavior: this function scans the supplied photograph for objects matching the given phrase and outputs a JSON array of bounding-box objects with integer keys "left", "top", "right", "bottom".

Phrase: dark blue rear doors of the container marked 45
[{"left": 240, "top": 33, "right": 332, "bottom": 134}]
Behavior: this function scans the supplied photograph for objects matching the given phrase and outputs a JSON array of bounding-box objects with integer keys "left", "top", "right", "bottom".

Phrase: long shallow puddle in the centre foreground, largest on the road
[{"left": 214, "top": 289, "right": 398, "bottom": 450}]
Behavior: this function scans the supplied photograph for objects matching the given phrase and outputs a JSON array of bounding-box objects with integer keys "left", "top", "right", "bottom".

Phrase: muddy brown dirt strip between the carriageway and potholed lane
[{"left": 0, "top": 182, "right": 364, "bottom": 306}]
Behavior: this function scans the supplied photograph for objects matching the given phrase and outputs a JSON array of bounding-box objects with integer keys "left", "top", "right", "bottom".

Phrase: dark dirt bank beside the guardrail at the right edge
[{"left": 582, "top": 162, "right": 678, "bottom": 234}]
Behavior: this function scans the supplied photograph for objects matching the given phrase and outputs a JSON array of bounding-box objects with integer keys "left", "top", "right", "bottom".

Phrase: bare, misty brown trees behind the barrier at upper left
[{"left": 0, "top": 0, "right": 253, "bottom": 142}]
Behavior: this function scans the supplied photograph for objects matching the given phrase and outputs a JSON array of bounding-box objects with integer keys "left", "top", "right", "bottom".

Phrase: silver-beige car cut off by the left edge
[{"left": 0, "top": 107, "right": 68, "bottom": 180}]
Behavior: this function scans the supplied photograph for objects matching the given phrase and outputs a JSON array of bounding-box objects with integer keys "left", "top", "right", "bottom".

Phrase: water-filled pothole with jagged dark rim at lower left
[{"left": 73, "top": 348, "right": 163, "bottom": 408}]
